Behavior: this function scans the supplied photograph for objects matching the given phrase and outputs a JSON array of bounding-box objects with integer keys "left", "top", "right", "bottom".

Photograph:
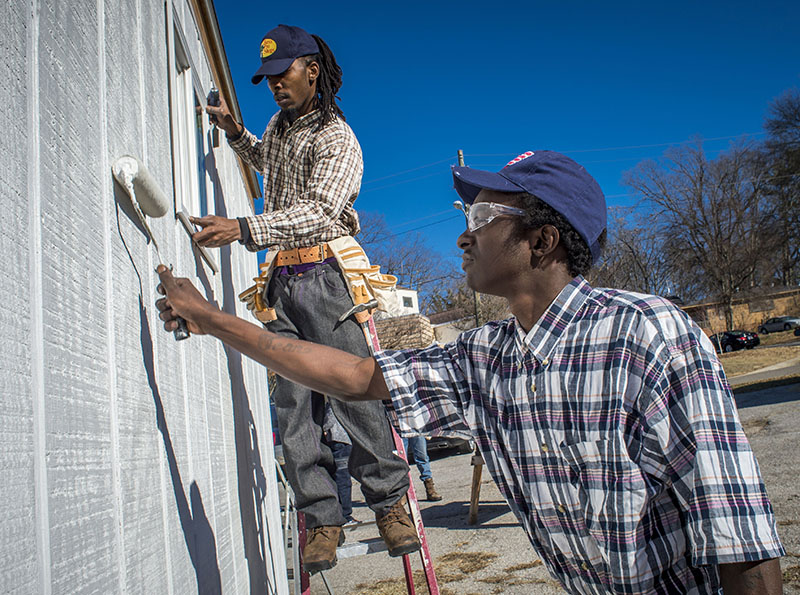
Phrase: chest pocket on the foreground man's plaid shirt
[{"left": 560, "top": 438, "right": 647, "bottom": 568}]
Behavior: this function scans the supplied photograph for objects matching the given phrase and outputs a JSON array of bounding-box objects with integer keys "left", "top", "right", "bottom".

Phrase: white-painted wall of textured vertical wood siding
[{"left": 0, "top": 0, "right": 286, "bottom": 594}]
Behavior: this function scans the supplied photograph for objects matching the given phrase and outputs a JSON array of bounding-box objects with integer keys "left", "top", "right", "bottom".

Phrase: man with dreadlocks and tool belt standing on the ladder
[{"left": 194, "top": 25, "right": 420, "bottom": 572}]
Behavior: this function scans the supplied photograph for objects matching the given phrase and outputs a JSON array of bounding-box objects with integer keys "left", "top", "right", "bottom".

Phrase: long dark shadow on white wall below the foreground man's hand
[{"left": 139, "top": 296, "right": 222, "bottom": 595}]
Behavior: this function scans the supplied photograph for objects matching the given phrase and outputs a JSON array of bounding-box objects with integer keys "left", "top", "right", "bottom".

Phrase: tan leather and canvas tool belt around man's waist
[{"left": 239, "top": 236, "right": 401, "bottom": 324}]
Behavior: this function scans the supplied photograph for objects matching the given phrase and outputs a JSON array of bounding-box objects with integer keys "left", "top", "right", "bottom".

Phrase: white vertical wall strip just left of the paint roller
[{"left": 97, "top": 0, "right": 128, "bottom": 593}]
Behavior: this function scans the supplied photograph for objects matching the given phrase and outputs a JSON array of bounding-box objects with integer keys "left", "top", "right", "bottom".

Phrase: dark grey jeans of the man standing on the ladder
[{"left": 266, "top": 263, "right": 409, "bottom": 528}]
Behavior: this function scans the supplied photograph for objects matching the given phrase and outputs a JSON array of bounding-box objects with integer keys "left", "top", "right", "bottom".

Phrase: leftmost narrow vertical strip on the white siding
[{"left": 27, "top": 0, "right": 52, "bottom": 595}]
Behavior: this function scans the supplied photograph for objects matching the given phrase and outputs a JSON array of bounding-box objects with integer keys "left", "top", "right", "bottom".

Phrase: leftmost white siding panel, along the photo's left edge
[{"left": 0, "top": 2, "right": 38, "bottom": 594}]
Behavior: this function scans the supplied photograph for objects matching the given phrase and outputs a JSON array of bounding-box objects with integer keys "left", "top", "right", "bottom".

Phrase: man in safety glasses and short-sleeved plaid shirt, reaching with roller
[{"left": 157, "top": 151, "right": 784, "bottom": 595}]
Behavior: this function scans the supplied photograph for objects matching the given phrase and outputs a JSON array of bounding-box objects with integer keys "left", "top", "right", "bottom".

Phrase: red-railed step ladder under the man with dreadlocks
[{"left": 276, "top": 317, "right": 439, "bottom": 595}]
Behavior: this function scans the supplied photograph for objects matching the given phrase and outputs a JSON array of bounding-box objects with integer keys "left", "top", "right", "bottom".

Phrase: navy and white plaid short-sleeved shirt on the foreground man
[{"left": 377, "top": 277, "right": 783, "bottom": 594}]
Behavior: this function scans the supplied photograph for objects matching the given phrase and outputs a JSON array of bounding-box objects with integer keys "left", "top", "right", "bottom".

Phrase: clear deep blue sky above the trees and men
[{"left": 216, "top": 0, "right": 800, "bottom": 257}]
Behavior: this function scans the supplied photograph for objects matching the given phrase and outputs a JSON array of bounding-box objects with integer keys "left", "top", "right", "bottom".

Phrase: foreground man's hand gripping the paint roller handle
[{"left": 156, "top": 264, "right": 218, "bottom": 335}]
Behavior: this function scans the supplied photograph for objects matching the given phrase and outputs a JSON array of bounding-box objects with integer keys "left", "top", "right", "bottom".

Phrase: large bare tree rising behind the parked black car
[{"left": 624, "top": 142, "right": 775, "bottom": 328}]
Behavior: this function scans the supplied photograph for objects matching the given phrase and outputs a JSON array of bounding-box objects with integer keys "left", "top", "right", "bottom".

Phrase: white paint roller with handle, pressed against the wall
[{"left": 111, "top": 155, "right": 189, "bottom": 341}]
